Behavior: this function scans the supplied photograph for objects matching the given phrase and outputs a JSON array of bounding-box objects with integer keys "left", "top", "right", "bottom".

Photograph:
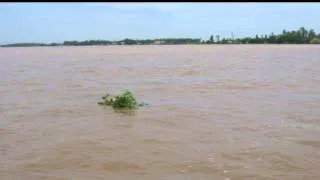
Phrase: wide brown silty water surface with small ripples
[{"left": 0, "top": 45, "right": 320, "bottom": 180}]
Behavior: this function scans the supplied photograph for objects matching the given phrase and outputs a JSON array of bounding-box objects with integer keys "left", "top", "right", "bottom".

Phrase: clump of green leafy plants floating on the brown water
[{"left": 98, "top": 90, "right": 146, "bottom": 109}]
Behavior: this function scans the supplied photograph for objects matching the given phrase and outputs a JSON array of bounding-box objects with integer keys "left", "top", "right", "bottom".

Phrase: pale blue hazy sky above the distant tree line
[{"left": 0, "top": 3, "right": 320, "bottom": 44}]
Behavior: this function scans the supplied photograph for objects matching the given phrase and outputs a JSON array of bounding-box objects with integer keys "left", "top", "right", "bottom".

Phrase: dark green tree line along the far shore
[{"left": 1, "top": 27, "right": 320, "bottom": 47}]
